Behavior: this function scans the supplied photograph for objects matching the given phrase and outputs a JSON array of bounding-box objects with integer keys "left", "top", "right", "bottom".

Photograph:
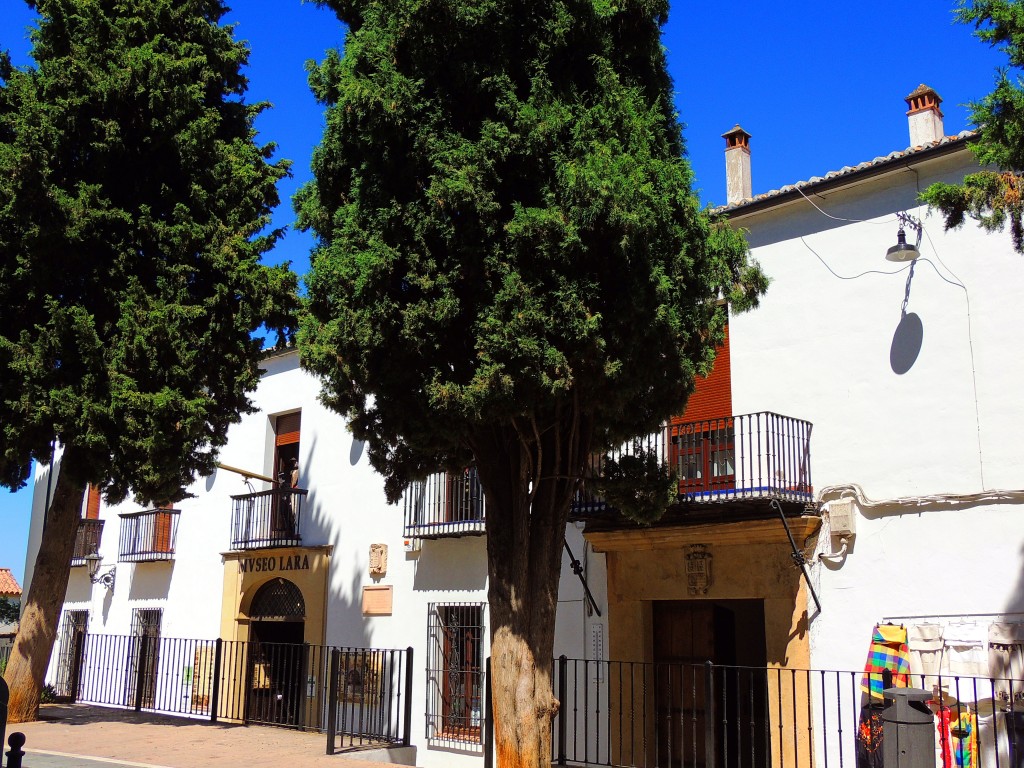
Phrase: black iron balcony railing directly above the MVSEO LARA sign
[{"left": 231, "top": 488, "right": 308, "bottom": 550}]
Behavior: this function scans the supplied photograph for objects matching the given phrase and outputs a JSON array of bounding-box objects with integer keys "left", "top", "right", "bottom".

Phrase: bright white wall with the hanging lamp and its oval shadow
[{"left": 730, "top": 147, "right": 1024, "bottom": 670}]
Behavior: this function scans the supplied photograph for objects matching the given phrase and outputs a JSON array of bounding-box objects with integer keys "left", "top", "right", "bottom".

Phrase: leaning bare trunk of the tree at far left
[{"left": 4, "top": 450, "right": 85, "bottom": 723}]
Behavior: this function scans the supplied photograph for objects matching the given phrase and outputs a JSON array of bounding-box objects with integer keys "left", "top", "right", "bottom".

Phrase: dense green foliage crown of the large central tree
[{"left": 296, "top": 0, "right": 766, "bottom": 499}]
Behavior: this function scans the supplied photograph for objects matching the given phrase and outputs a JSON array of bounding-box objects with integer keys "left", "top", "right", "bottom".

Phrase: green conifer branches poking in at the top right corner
[{"left": 922, "top": 0, "right": 1024, "bottom": 253}]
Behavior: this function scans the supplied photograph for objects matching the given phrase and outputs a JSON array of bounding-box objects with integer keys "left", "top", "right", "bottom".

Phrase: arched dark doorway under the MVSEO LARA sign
[{"left": 247, "top": 578, "right": 306, "bottom": 727}]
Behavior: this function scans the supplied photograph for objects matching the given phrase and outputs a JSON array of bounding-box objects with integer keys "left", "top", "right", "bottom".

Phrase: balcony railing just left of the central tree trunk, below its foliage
[{"left": 406, "top": 468, "right": 485, "bottom": 539}]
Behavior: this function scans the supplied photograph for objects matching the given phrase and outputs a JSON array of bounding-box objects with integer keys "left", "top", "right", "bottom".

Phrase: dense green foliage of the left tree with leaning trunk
[{"left": 0, "top": 0, "right": 295, "bottom": 502}]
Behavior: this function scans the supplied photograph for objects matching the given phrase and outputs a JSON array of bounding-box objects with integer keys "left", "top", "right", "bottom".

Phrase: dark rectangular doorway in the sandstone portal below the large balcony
[{"left": 653, "top": 600, "right": 769, "bottom": 768}]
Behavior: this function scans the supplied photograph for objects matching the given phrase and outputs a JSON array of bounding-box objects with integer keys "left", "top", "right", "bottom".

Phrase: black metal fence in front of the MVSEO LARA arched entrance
[{"left": 44, "top": 632, "right": 412, "bottom": 750}]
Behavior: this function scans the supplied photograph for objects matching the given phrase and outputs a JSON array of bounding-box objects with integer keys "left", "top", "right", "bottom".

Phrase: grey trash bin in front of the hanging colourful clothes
[{"left": 882, "top": 688, "right": 935, "bottom": 768}]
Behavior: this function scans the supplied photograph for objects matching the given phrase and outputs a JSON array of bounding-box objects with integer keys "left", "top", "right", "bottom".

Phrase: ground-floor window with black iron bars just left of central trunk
[{"left": 427, "top": 603, "right": 484, "bottom": 744}]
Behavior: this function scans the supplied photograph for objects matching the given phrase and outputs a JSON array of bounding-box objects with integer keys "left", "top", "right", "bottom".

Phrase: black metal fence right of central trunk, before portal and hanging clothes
[{"left": 552, "top": 657, "right": 1024, "bottom": 768}]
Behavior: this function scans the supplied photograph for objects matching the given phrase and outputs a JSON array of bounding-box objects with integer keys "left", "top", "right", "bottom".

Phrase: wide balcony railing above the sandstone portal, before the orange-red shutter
[{"left": 573, "top": 412, "right": 814, "bottom": 515}]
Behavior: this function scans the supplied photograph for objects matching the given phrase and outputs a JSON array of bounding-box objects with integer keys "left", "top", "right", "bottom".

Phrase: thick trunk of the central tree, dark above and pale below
[{"left": 473, "top": 409, "right": 590, "bottom": 768}]
